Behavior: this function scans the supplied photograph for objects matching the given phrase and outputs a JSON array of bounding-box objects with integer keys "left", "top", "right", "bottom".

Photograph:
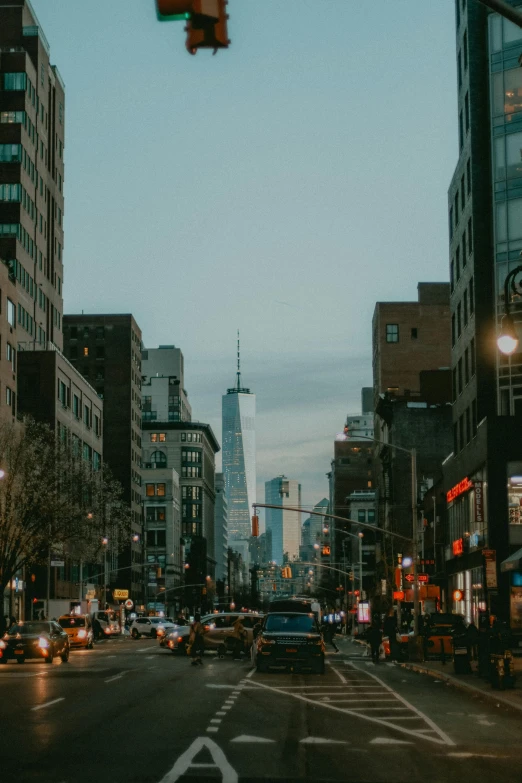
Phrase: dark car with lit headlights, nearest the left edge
[{"left": 0, "top": 620, "right": 69, "bottom": 663}]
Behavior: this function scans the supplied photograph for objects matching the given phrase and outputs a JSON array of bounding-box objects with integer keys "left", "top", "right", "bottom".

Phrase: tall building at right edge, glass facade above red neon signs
[{"left": 444, "top": 0, "right": 522, "bottom": 635}]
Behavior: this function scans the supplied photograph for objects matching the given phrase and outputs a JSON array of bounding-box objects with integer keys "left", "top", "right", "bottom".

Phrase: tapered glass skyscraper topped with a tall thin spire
[{"left": 222, "top": 332, "right": 256, "bottom": 562}]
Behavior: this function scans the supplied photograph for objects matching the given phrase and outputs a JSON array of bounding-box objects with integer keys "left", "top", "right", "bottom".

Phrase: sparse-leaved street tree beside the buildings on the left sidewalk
[{"left": 0, "top": 418, "right": 130, "bottom": 595}]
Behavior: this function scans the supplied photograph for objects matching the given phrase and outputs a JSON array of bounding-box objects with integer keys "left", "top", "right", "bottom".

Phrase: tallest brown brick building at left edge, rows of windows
[{"left": 0, "top": 0, "right": 65, "bottom": 418}]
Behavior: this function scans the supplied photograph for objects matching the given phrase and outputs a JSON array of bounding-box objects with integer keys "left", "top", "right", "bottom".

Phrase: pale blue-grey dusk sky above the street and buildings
[{"left": 32, "top": 0, "right": 458, "bottom": 507}]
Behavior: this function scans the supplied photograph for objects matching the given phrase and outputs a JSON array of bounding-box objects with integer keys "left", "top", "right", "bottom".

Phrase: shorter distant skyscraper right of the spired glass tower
[{"left": 265, "top": 476, "right": 301, "bottom": 565}]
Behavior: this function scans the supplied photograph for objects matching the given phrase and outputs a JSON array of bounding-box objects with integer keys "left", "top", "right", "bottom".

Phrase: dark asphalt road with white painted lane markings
[{"left": 0, "top": 639, "right": 522, "bottom": 783}]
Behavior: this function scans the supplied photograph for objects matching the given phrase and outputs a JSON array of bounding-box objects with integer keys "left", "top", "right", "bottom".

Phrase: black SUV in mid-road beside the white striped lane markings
[{"left": 254, "top": 612, "right": 324, "bottom": 674}]
